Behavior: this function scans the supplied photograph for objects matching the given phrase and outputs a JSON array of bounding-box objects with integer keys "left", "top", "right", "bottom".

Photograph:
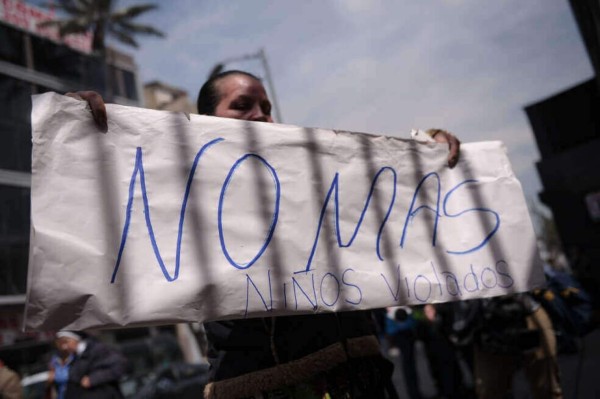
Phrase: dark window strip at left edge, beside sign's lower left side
[{"left": 0, "top": 186, "right": 30, "bottom": 295}]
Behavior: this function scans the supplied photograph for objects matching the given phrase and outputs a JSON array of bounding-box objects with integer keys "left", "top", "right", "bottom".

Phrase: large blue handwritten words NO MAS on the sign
[{"left": 111, "top": 138, "right": 500, "bottom": 283}]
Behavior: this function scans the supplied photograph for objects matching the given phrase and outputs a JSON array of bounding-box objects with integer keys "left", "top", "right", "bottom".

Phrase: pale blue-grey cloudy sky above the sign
[{"left": 112, "top": 0, "right": 593, "bottom": 203}]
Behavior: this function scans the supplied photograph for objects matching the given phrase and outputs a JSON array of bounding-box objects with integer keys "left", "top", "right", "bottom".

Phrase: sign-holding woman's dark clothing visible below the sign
[{"left": 205, "top": 311, "right": 391, "bottom": 398}]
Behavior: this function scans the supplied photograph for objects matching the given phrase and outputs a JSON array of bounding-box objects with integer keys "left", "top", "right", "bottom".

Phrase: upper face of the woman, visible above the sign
[{"left": 214, "top": 75, "right": 273, "bottom": 122}]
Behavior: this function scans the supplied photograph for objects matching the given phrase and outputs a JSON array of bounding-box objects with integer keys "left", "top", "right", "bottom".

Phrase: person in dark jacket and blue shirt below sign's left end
[{"left": 56, "top": 331, "right": 127, "bottom": 399}]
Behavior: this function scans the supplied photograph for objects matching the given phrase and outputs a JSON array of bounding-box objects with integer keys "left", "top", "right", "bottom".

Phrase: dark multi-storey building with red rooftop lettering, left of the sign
[{"left": 0, "top": 0, "right": 141, "bottom": 376}]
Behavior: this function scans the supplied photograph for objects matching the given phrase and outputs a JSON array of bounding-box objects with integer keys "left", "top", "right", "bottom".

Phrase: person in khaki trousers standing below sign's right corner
[{"left": 475, "top": 293, "right": 563, "bottom": 399}]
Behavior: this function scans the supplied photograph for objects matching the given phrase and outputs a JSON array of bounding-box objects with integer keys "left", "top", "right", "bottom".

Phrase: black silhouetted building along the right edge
[{"left": 525, "top": 0, "right": 600, "bottom": 292}]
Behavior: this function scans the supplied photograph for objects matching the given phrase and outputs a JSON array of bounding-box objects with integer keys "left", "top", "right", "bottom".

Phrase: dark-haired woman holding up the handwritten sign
[{"left": 70, "top": 71, "right": 460, "bottom": 399}]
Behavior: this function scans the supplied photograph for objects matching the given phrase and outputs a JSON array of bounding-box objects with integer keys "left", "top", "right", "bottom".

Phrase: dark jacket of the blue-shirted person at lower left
[{"left": 65, "top": 340, "right": 126, "bottom": 399}]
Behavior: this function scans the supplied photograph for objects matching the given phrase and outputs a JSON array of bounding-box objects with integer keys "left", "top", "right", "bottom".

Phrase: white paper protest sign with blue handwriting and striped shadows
[{"left": 26, "top": 93, "right": 543, "bottom": 329}]
